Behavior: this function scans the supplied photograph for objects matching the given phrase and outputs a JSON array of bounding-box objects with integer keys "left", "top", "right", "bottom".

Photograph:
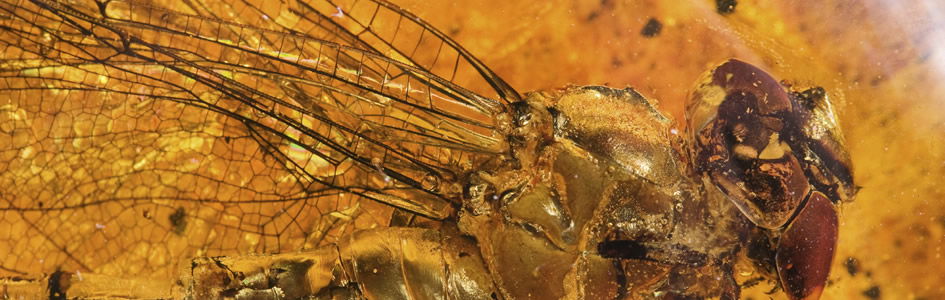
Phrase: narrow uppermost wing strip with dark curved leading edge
[{"left": 166, "top": 0, "right": 521, "bottom": 102}]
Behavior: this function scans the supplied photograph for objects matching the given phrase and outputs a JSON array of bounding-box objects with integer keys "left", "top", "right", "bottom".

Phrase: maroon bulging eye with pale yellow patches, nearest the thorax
[{"left": 687, "top": 60, "right": 810, "bottom": 229}]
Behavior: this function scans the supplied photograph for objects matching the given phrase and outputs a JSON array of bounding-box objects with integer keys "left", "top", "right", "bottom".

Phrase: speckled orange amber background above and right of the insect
[{"left": 396, "top": 0, "right": 945, "bottom": 299}]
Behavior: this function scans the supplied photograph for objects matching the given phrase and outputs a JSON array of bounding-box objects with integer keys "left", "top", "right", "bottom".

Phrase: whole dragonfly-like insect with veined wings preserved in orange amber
[{"left": 0, "top": 0, "right": 853, "bottom": 299}]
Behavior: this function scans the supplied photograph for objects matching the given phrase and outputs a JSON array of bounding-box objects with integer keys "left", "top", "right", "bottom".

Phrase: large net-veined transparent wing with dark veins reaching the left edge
[{"left": 0, "top": 1, "right": 507, "bottom": 276}]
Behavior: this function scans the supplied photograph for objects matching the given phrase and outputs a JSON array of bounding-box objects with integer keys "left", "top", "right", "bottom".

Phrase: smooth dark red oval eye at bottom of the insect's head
[{"left": 775, "top": 191, "right": 837, "bottom": 299}]
